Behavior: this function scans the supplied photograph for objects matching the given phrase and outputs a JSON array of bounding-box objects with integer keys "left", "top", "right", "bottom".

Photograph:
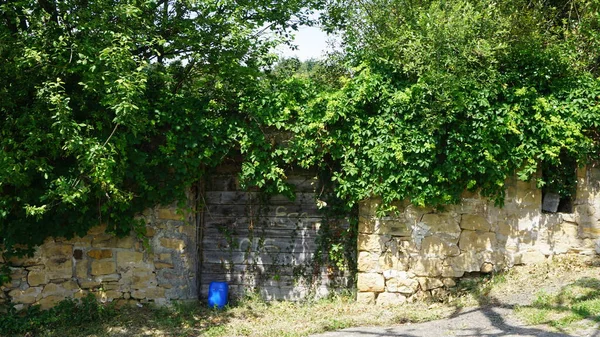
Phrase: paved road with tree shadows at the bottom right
[{"left": 311, "top": 307, "right": 600, "bottom": 337}]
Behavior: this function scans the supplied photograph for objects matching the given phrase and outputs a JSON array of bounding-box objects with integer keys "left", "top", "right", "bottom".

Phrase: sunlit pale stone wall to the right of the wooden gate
[{"left": 357, "top": 168, "right": 600, "bottom": 304}]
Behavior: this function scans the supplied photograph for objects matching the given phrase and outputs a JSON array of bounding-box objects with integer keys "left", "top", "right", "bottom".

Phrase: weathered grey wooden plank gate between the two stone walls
[{"left": 200, "top": 168, "right": 332, "bottom": 300}]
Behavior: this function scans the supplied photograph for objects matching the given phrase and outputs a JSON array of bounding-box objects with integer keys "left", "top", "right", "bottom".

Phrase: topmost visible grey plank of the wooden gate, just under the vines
[{"left": 204, "top": 191, "right": 316, "bottom": 206}]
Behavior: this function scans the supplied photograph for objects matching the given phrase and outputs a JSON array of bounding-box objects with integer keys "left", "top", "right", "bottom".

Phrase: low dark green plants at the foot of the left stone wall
[{"left": 0, "top": 294, "right": 115, "bottom": 336}]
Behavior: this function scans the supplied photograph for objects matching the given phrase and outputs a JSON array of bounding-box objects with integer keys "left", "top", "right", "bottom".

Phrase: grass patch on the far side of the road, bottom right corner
[{"left": 515, "top": 277, "right": 600, "bottom": 329}]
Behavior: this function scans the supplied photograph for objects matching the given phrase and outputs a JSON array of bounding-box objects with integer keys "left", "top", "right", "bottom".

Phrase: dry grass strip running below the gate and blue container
[{"left": 0, "top": 295, "right": 452, "bottom": 337}]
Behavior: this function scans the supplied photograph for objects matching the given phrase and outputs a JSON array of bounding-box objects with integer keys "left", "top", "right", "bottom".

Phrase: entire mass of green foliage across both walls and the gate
[{"left": 0, "top": 0, "right": 600, "bottom": 253}]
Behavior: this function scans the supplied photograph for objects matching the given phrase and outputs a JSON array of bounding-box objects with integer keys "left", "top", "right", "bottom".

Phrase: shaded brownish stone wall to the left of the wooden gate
[{"left": 0, "top": 202, "right": 197, "bottom": 309}]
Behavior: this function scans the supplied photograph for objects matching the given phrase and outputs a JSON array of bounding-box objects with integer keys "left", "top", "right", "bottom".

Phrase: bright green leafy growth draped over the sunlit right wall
[{"left": 268, "top": 0, "right": 600, "bottom": 205}]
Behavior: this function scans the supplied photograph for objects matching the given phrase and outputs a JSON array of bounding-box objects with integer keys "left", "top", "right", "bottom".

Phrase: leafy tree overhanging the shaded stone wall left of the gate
[{"left": 0, "top": 0, "right": 320, "bottom": 251}]
